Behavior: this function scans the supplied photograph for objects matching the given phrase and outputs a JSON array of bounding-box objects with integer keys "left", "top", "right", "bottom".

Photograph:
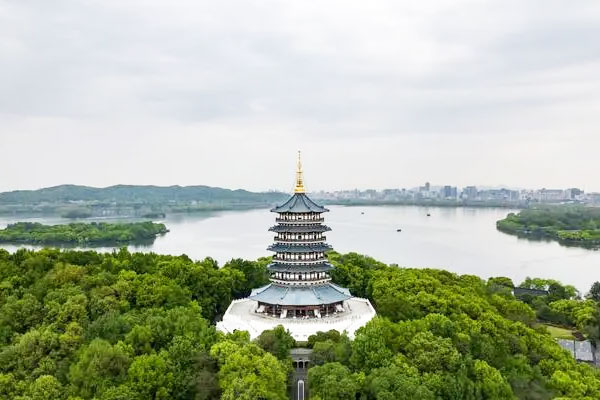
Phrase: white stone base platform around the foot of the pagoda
[{"left": 217, "top": 297, "right": 376, "bottom": 341}]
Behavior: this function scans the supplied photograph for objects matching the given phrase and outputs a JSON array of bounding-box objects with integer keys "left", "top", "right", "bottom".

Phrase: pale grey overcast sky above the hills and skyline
[{"left": 0, "top": 0, "right": 600, "bottom": 191}]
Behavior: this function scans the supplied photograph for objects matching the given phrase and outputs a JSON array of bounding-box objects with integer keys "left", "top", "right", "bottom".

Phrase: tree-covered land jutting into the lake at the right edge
[{"left": 496, "top": 206, "right": 600, "bottom": 248}]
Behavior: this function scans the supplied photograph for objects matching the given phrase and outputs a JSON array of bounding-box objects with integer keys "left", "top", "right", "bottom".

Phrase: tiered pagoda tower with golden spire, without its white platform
[{"left": 250, "top": 152, "right": 352, "bottom": 318}]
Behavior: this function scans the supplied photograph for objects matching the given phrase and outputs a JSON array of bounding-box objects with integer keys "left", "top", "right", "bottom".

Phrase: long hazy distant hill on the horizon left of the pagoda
[{"left": 0, "top": 185, "right": 287, "bottom": 204}]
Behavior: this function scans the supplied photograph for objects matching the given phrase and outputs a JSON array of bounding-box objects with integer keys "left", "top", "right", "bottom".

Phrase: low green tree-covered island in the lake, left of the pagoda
[{"left": 0, "top": 222, "right": 168, "bottom": 246}]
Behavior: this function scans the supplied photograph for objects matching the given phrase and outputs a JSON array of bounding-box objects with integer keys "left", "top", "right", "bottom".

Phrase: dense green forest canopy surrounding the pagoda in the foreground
[{"left": 0, "top": 249, "right": 600, "bottom": 400}]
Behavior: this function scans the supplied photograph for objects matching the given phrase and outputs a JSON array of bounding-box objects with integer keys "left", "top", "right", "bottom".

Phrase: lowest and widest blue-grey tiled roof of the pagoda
[{"left": 250, "top": 282, "right": 352, "bottom": 306}]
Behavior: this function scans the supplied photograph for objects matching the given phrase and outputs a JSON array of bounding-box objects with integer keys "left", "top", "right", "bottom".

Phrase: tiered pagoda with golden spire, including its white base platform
[{"left": 217, "top": 152, "right": 375, "bottom": 341}]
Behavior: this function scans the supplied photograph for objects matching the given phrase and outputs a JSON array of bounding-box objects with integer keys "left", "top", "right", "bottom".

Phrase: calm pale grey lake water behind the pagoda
[{"left": 0, "top": 206, "right": 600, "bottom": 293}]
